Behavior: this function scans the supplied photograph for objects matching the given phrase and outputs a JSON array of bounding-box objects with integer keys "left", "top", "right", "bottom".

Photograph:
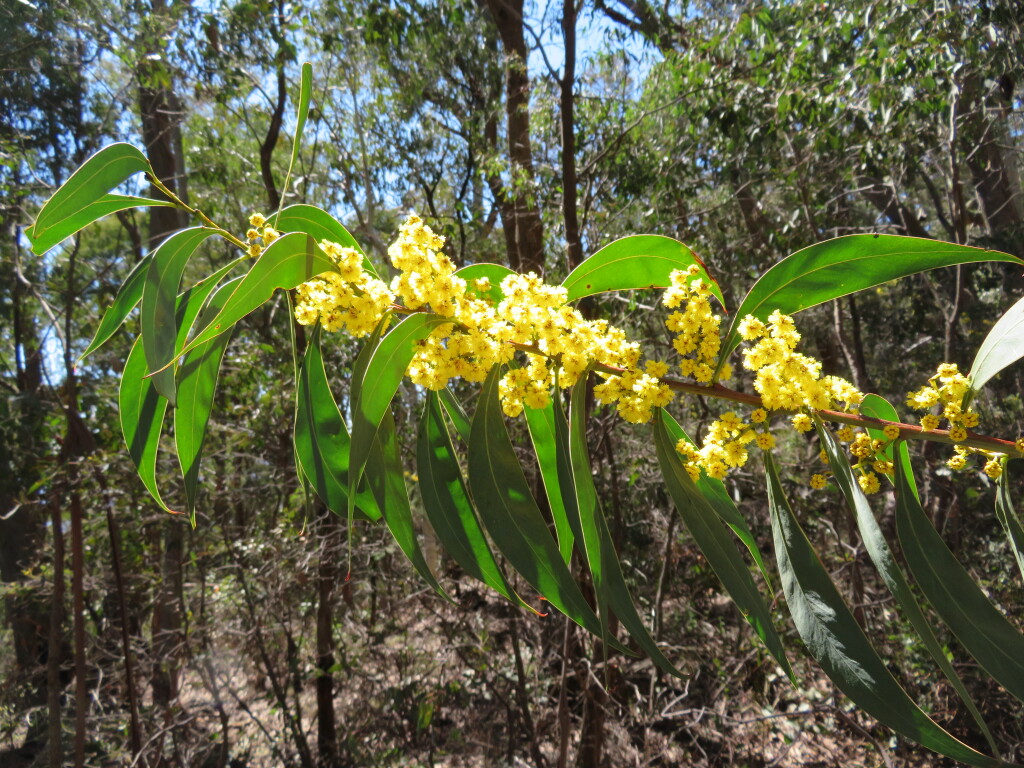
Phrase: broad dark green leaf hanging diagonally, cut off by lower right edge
[{"left": 896, "top": 456, "right": 1024, "bottom": 701}]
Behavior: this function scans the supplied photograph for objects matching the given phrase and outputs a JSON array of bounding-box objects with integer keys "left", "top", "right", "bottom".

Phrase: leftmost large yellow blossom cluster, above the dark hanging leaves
[{"left": 295, "top": 241, "right": 394, "bottom": 336}]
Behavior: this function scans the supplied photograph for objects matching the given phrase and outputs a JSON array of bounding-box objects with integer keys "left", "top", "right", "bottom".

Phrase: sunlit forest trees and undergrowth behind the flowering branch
[{"left": 0, "top": 0, "right": 1024, "bottom": 766}]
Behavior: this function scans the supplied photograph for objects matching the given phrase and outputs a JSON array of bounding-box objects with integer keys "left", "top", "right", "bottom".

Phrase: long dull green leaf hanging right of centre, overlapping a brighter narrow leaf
[{"left": 654, "top": 409, "right": 794, "bottom": 679}]
